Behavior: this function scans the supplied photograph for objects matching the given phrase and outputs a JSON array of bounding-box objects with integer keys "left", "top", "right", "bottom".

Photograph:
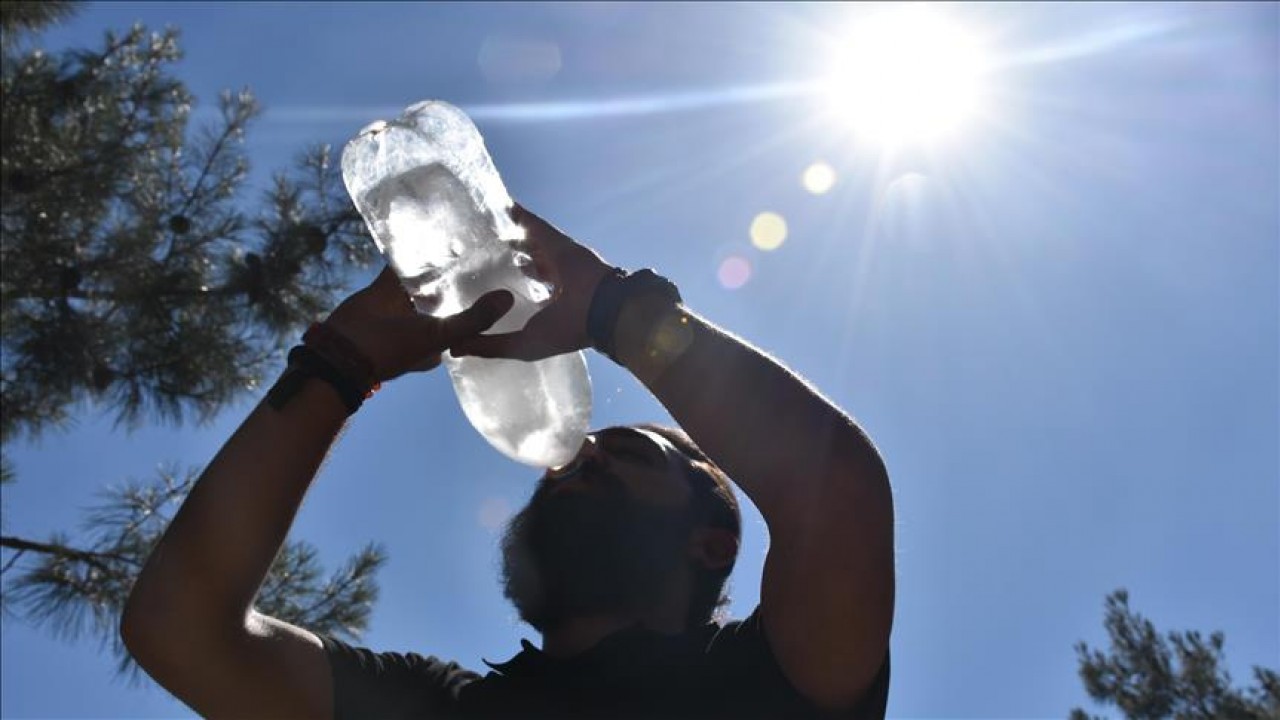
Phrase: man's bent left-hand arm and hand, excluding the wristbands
[{"left": 120, "top": 266, "right": 511, "bottom": 717}]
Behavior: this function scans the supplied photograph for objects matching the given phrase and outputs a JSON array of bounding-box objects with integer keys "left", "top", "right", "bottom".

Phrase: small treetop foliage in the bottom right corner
[{"left": 1071, "top": 589, "right": 1280, "bottom": 720}]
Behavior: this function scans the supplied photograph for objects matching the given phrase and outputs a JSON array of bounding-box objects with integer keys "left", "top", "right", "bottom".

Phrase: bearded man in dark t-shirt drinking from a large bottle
[{"left": 122, "top": 208, "right": 893, "bottom": 717}]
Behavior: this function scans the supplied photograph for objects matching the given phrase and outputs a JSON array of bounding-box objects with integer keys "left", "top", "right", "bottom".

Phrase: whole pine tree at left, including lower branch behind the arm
[{"left": 0, "top": 1, "right": 385, "bottom": 669}]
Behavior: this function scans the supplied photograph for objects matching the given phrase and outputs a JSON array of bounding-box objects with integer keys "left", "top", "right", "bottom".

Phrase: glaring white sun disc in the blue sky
[{"left": 823, "top": 4, "right": 988, "bottom": 146}]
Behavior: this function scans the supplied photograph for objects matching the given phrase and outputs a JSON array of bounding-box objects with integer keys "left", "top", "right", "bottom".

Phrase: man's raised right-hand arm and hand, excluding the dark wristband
[{"left": 453, "top": 208, "right": 895, "bottom": 707}]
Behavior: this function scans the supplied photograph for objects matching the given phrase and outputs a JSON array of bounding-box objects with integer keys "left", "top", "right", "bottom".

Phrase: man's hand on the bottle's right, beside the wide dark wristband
[{"left": 449, "top": 205, "right": 612, "bottom": 360}]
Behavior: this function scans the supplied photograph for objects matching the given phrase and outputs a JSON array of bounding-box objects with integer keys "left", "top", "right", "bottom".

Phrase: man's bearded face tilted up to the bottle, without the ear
[{"left": 502, "top": 428, "right": 691, "bottom": 632}]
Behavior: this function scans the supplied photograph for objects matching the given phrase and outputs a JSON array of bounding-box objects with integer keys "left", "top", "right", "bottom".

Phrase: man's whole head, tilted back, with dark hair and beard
[{"left": 502, "top": 424, "right": 741, "bottom": 633}]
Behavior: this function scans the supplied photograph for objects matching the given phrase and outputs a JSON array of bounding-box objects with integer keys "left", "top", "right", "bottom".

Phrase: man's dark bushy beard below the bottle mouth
[{"left": 502, "top": 461, "right": 691, "bottom": 632}]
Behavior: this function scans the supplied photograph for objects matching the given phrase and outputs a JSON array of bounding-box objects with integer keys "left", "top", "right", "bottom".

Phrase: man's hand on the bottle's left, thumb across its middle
[{"left": 326, "top": 266, "right": 513, "bottom": 382}]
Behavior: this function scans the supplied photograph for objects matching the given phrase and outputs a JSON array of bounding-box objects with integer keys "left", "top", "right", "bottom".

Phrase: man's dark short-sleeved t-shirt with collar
[{"left": 321, "top": 610, "right": 888, "bottom": 720}]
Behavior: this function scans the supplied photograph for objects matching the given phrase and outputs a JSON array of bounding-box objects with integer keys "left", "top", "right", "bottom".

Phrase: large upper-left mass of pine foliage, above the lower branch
[{"left": 0, "top": 19, "right": 371, "bottom": 439}]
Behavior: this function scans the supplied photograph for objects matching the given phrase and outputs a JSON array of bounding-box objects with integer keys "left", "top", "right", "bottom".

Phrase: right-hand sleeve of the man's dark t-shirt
[{"left": 709, "top": 606, "right": 890, "bottom": 720}]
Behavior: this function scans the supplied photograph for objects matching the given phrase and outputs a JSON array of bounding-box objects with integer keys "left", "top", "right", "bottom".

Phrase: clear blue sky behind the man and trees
[{"left": 0, "top": 3, "right": 1280, "bottom": 717}]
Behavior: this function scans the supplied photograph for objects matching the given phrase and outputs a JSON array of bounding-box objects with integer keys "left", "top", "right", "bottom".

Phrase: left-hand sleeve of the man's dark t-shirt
[{"left": 320, "top": 635, "right": 479, "bottom": 720}]
